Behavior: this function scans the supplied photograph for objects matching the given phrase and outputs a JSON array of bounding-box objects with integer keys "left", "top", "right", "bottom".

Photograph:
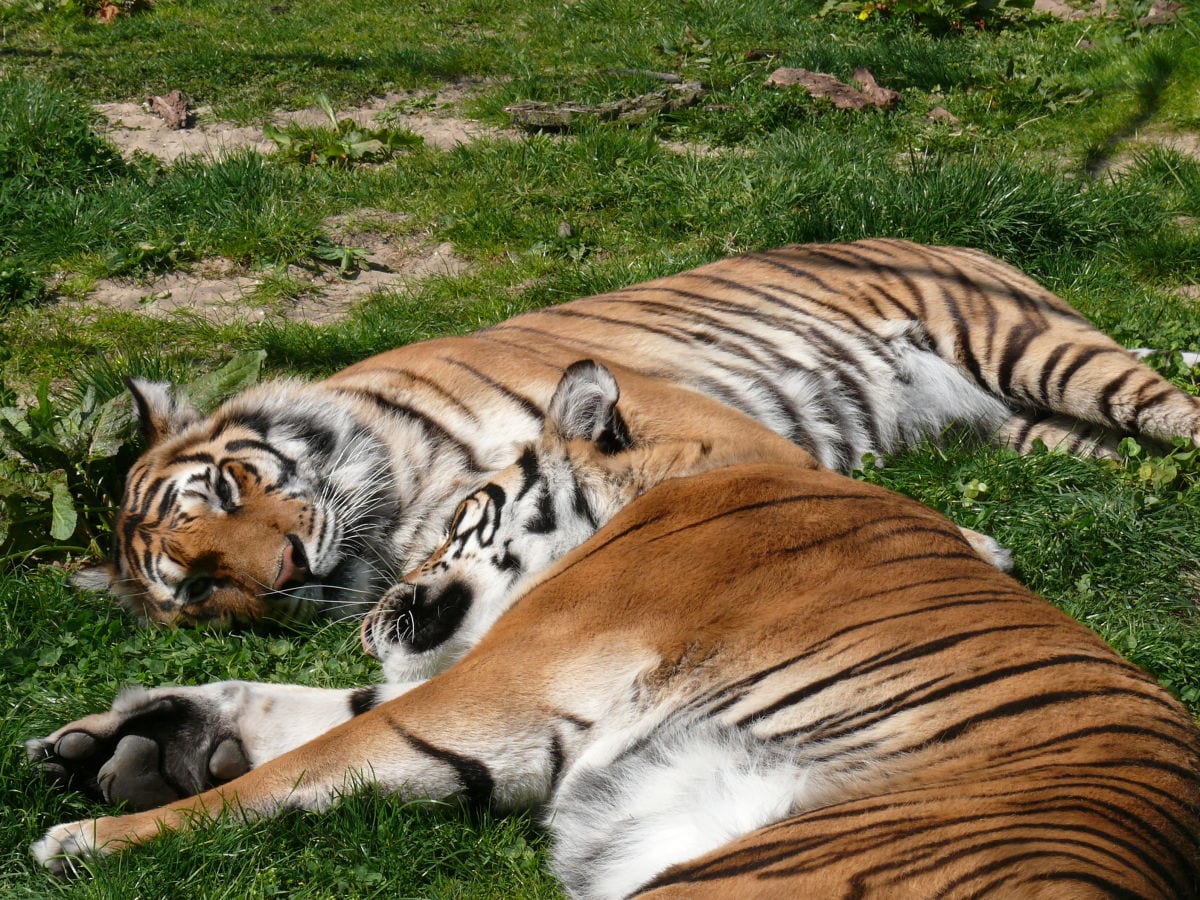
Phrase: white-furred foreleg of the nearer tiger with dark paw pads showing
[{"left": 25, "top": 682, "right": 413, "bottom": 810}]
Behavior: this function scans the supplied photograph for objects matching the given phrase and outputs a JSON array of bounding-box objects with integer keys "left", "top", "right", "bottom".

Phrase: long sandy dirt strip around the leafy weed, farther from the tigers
[{"left": 96, "top": 89, "right": 516, "bottom": 162}]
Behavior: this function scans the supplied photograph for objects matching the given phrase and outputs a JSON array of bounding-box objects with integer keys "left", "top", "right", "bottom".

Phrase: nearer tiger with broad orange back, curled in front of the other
[{"left": 30, "top": 367, "right": 1200, "bottom": 898}]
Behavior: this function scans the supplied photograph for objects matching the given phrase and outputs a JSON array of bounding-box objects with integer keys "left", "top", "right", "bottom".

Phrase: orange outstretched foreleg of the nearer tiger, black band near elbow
[{"left": 32, "top": 677, "right": 562, "bottom": 875}]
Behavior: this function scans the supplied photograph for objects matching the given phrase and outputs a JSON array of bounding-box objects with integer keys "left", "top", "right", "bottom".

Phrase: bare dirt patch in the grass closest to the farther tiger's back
[{"left": 85, "top": 210, "right": 469, "bottom": 324}]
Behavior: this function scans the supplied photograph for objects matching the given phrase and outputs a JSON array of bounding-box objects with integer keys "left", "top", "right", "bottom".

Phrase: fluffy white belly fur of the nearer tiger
[{"left": 546, "top": 718, "right": 880, "bottom": 899}]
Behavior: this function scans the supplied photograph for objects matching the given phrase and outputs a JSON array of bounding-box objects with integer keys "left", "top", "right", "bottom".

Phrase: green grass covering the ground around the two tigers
[{"left": 0, "top": 0, "right": 1200, "bottom": 898}]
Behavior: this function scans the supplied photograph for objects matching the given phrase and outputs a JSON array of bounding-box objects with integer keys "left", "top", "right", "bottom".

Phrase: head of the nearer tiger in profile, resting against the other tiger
[{"left": 362, "top": 360, "right": 792, "bottom": 682}]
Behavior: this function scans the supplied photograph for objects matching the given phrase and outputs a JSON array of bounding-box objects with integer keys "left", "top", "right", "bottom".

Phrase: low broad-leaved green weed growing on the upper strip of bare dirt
[{"left": 263, "top": 94, "right": 424, "bottom": 166}]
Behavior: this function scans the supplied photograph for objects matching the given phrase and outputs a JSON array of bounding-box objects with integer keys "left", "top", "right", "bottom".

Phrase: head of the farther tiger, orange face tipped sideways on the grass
[{"left": 74, "top": 379, "right": 391, "bottom": 625}]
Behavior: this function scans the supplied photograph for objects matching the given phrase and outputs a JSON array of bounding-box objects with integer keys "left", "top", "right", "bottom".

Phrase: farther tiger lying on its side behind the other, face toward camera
[{"left": 78, "top": 240, "right": 1200, "bottom": 624}]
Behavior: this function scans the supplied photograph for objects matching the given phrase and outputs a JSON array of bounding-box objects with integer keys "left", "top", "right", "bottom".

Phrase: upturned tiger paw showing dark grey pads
[{"left": 25, "top": 689, "right": 251, "bottom": 810}]
